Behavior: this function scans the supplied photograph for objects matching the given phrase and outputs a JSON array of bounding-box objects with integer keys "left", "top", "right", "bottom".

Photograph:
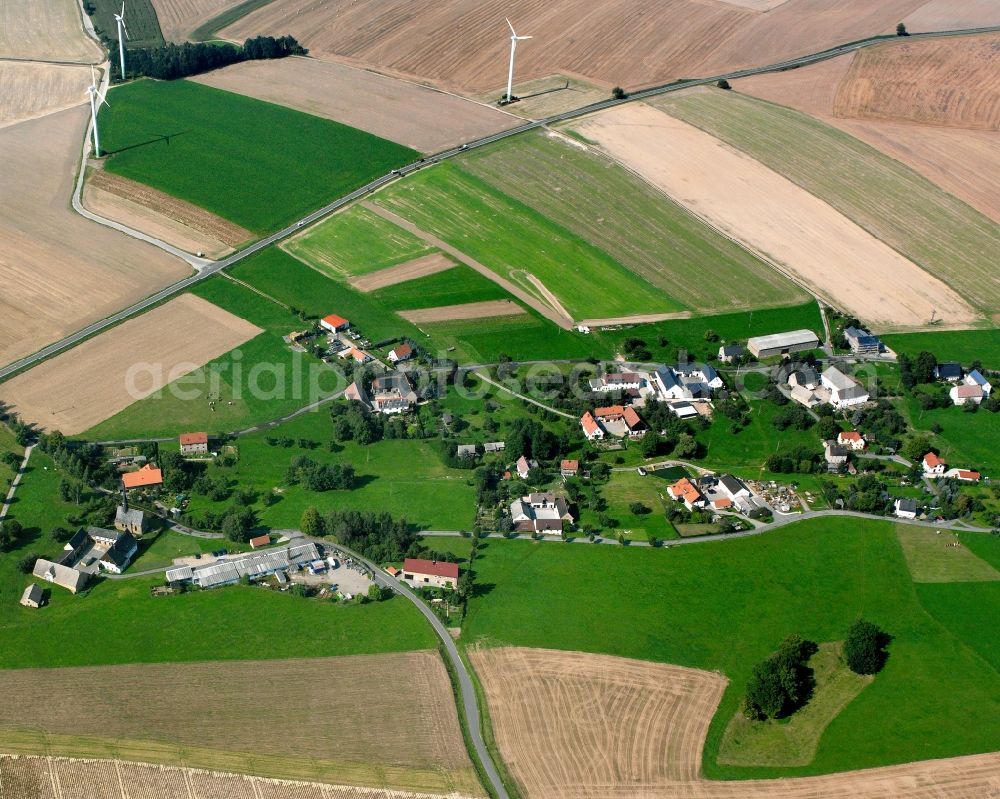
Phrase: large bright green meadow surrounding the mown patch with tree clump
[{"left": 462, "top": 519, "right": 1000, "bottom": 778}]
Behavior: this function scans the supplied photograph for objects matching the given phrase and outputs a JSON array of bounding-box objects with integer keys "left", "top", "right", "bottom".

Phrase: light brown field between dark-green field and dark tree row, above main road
[{"left": 193, "top": 57, "right": 518, "bottom": 153}]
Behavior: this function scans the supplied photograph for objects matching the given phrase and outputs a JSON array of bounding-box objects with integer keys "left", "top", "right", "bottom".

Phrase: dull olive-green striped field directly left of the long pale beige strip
[{"left": 460, "top": 131, "right": 807, "bottom": 313}]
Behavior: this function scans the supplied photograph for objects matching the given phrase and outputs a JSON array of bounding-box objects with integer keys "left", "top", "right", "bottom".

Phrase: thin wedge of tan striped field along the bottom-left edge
[{"left": 0, "top": 755, "right": 480, "bottom": 799}]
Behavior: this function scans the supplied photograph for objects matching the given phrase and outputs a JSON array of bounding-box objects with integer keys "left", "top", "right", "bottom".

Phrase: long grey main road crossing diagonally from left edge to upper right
[{"left": 0, "top": 25, "right": 1000, "bottom": 381}]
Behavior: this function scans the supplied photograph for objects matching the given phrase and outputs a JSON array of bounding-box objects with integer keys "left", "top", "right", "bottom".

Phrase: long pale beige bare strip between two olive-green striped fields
[{"left": 576, "top": 104, "right": 976, "bottom": 329}]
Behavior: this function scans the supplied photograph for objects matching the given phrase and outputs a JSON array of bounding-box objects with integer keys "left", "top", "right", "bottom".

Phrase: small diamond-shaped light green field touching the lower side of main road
[{"left": 282, "top": 205, "right": 434, "bottom": 280}]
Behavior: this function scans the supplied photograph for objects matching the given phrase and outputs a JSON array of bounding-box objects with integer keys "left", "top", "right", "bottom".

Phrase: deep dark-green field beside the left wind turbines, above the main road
[{"left": 100, "top": 80, "right": 417, "bottom": 233}]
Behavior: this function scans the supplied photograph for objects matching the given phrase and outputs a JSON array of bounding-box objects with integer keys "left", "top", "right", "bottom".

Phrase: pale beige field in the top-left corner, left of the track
[{"left": 0, "top": 0, "right": 103, "bottom": 64}]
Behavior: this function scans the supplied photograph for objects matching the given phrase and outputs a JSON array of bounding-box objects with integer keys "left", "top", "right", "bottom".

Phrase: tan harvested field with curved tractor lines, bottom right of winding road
[{"left": 470, "top": 647, "right": 1000, "bottom": 799}]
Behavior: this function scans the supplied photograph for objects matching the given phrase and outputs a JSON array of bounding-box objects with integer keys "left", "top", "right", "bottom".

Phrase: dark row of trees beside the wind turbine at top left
[{"left": 110, "top": 36, "right": 308, "bottom": 81}]
